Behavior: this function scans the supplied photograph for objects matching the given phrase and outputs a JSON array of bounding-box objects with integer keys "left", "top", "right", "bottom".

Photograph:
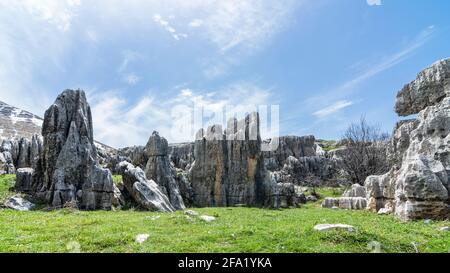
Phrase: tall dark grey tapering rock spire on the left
[{"left": 33, "top": 90, "right": 113, "bottom": 210}]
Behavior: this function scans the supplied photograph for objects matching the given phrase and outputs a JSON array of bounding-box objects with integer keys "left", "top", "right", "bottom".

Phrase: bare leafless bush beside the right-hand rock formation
[{"left": 341, "top": 117, "right": 389, "bottom": 185}]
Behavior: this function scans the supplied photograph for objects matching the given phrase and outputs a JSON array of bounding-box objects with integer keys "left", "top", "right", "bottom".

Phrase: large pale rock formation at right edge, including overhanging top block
[{"left": 365, "top": 60, "right": 450, "bottom": 220}]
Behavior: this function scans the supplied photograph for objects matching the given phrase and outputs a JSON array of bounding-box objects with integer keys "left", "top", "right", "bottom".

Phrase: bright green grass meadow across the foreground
[{"left": 0, "top": 174, "right": 450, "bottom": 252}]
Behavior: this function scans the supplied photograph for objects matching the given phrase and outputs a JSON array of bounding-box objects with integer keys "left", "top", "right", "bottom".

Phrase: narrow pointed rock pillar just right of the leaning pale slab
[{"left": 145, "top": 132, "right": 185, "bottom": 210}]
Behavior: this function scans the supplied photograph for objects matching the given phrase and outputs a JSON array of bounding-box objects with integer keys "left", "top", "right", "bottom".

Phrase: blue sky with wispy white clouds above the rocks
[{"left": 0, "top": 0, "right": 450, "bottom": 147}]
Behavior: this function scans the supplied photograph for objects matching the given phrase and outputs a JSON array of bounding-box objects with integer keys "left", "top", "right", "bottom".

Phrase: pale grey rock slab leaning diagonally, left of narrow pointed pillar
[{"left": 118, "top": 161, "right": 175, "bottom": 212}]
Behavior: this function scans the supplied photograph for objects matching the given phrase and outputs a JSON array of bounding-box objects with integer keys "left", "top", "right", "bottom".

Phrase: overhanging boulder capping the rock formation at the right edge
[{"left": 395, "top": 59, "right": 450, "bottom": 116}]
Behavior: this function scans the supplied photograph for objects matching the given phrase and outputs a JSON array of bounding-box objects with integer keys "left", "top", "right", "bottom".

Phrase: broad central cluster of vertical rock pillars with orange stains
[{"left": 191, "top": 113, "right": 265, "bottom": 206}]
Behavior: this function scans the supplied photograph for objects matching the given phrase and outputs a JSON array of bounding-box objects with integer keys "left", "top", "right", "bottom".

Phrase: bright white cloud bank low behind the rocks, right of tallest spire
[{"left": 89, "top": 82, "right": 272, "bottom": 147}]
